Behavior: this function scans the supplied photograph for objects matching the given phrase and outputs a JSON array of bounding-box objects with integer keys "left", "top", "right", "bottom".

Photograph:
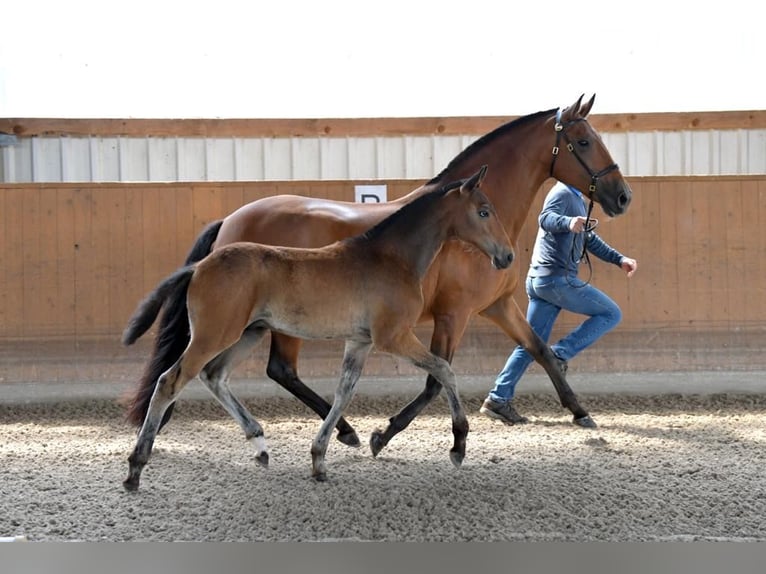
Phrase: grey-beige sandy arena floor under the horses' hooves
[{"left": 0, "top": 393, "right": 766, "bottom": 541}]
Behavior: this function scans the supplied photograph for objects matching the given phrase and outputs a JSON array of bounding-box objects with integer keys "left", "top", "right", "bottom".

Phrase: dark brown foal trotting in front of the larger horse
[{"left": 123, "top": 166, "right": 513, "bottom": 490}]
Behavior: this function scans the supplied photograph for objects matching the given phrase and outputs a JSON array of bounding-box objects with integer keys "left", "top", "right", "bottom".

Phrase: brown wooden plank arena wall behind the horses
[{"left": 0, "top": 176, "right": 766, "bottom": 382}]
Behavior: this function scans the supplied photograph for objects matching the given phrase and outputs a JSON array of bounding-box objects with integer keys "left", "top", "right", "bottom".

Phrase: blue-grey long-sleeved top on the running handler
[{"left": 529, "top": 182, "right": 623, "bottom": 277}]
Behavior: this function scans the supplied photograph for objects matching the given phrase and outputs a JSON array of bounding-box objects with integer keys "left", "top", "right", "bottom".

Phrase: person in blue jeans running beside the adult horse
[{"left": 479, "top": 182, "right": 638, "bottom": 425}]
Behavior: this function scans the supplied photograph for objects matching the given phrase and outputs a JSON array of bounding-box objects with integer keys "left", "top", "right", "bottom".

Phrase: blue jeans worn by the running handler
[{"left": 489, "top": 276, "right": 622, "bottom": 402}]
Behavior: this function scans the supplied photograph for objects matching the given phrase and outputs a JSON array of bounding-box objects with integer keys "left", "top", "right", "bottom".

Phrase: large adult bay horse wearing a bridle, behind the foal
[{"left": 127, "top": 95, "right": 631, "bottom": 455}]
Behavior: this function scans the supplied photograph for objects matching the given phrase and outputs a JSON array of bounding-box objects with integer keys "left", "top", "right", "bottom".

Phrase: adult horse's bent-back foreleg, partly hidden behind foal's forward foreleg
[{"left": 370, "top": 314, "right": 468, "bottom": 456}]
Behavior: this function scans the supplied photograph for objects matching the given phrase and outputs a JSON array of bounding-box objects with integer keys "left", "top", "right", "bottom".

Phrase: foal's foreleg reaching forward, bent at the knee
[{"left": 375, "top": 331, "right": 468, "bottom": 467}]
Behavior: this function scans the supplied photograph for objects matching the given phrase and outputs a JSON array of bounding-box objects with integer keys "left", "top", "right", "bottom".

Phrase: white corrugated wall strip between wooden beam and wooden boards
[{"left": 0, "top": 130, "right": 766, "bottom": 183}]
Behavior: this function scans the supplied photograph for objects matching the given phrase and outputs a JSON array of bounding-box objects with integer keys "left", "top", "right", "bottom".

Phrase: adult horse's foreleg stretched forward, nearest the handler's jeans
[{"left": 480, "top": 294, "right": 596, "bottom": 428}]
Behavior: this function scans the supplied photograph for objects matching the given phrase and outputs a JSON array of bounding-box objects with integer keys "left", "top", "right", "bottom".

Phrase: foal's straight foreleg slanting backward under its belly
[{"left": 311, "top": 341, "right": 372, "bottom": 482}]
